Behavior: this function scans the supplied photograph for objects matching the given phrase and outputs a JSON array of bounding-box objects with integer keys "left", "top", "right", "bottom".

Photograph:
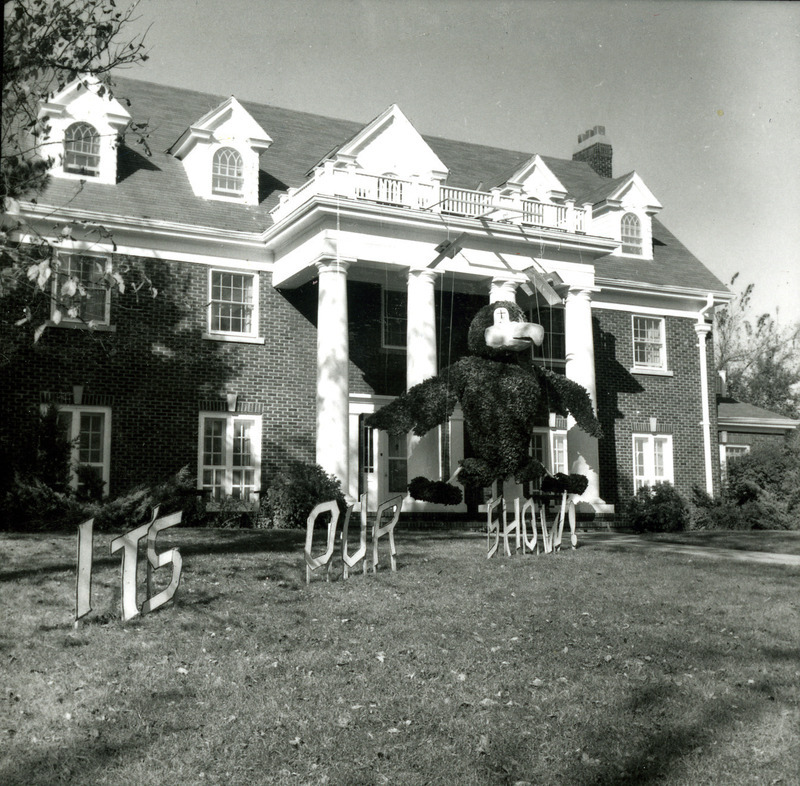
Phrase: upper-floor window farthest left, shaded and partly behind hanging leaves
[{"left": 53, "top": 254, "right": 111, "bottom": 325}]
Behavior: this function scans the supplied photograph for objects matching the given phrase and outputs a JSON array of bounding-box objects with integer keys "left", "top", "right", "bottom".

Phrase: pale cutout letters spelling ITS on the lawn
[{"left": 75, "top": 508, "right": 183, "bottom": 623}]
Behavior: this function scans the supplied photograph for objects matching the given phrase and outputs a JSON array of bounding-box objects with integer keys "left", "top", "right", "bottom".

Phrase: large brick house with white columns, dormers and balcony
[{"left": 2, "top": 79, "right": 752, "bottom": 514}]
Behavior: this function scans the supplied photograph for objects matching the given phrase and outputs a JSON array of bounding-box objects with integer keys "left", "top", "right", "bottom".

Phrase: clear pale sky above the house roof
[{"left": 120, "top": 0, "right": 800, "bottom": 325}]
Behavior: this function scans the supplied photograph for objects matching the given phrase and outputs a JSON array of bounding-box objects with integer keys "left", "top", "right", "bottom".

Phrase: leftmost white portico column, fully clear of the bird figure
[{"left": 317, "top": 259, "right": 350, "bottom": 493}]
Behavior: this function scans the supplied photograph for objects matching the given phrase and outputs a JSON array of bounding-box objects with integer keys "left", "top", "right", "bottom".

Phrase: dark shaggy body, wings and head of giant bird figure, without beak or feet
[{"left": 367, "top": 302, "right": 602, "bottom": 496}]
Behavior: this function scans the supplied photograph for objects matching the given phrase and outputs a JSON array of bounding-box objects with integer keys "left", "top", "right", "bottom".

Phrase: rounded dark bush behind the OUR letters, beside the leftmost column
[{"left": 266, "top": 461, "right": 347, "bottom": 529}]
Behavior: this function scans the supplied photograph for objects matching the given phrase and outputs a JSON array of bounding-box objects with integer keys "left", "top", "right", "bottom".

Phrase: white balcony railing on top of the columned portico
[{"left": 272, "top": 167, "right": 587, "bottom": 232}]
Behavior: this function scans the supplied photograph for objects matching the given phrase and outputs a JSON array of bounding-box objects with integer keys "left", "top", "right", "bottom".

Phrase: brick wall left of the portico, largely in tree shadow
[{"left": 0, "top": 254, "right": 316, "bottom": 493}]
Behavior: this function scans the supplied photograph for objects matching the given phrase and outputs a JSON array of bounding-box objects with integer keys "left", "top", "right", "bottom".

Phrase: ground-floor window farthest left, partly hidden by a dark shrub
[{"left": 53, "top": 406, "right": 111, "bottom": 496}]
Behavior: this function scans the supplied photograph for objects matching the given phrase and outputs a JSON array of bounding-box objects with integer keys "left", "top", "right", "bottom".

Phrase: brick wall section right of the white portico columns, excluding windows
[{"left": 592, "top": 309, "right": 719, "bottom": 505}]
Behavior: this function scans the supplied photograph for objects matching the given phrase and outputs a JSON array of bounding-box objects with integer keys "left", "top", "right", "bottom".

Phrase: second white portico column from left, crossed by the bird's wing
[{"left": 406, "top": 268, "right": 440, "bottom": 480}]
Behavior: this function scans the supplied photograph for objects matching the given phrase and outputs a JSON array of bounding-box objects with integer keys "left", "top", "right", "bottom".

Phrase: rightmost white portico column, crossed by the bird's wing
[{"left": 564, "top": 288, "right": 602, "bottom": 503}]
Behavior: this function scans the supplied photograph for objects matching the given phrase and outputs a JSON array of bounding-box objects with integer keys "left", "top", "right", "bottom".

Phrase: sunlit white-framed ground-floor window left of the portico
[{"left": 199, "top": 414, "right": 261, "bottom": 502}]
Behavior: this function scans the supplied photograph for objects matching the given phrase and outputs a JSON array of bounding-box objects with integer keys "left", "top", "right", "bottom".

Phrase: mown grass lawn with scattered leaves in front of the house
[{"left": 0, "top": 530, "right": 800, "bottom": 786}]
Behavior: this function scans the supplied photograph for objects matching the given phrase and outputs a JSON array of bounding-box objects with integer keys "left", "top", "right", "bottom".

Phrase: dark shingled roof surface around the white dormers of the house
[{"left": 21, "top": 77, "right": 726, "bottom": 292}]
